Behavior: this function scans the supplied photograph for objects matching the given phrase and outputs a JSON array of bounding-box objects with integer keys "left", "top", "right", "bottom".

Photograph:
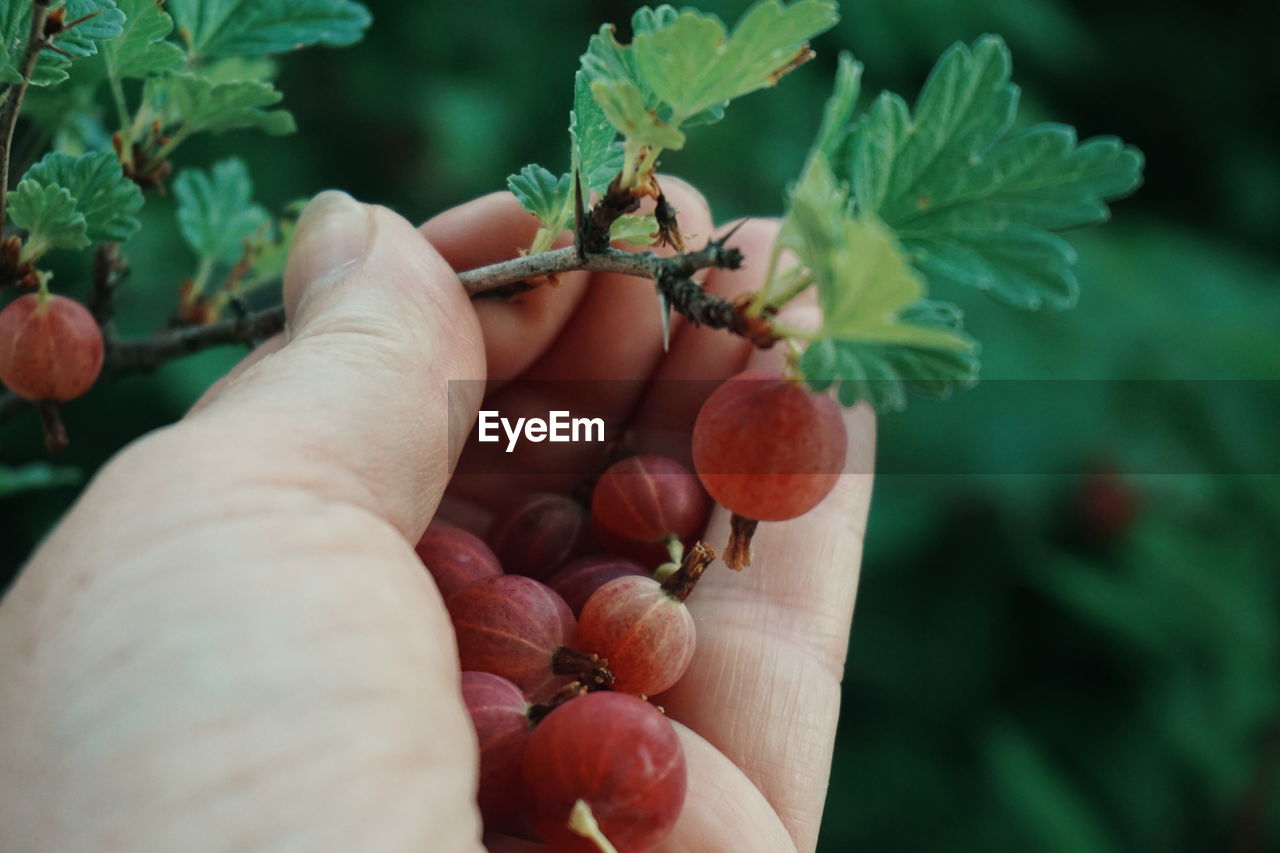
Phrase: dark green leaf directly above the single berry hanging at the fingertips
[{"left": 800, "top": 301, "right": 978, "bottom": 412}]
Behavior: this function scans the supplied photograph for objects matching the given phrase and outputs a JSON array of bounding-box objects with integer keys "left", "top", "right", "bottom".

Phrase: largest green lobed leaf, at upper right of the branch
[{"left": 842, "top": 36, "right": 1143, "bottom": 309}]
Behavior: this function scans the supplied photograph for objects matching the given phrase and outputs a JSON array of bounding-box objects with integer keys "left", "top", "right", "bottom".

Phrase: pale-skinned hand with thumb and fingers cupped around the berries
[{"left": 0, "top": 179, "right": 874, "bottom": 853}]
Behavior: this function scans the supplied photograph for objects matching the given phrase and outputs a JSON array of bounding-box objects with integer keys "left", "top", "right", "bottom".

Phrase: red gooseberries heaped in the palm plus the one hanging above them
[{"left": 427, "top": 371, "right": 846, "bottom": 853}]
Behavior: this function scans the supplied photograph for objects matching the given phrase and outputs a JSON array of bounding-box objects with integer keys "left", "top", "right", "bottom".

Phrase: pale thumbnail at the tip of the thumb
[{"left": 284, "top": 190, "right": 372, "bottom": 314}]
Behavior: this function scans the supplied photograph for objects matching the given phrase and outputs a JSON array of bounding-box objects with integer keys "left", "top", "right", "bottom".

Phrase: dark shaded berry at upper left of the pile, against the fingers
[{"left": 488, "top": 492, "right": 586, "bottom": 580}]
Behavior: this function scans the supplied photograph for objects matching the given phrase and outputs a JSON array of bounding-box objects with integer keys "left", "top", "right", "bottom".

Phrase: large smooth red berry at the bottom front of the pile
[{"left": 525, "top": 692, "right": 687, "bottom": 853}]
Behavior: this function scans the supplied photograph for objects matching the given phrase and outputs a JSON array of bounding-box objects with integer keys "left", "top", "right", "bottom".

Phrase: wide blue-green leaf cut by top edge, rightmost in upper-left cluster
[{"left": 169, "top": 0, "right": 371, "bottom": 56}]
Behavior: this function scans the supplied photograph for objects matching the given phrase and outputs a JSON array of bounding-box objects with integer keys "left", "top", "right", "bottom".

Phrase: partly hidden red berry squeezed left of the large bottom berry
[{"left": 462, "top": 672, "right": 534, "bottom": 830}]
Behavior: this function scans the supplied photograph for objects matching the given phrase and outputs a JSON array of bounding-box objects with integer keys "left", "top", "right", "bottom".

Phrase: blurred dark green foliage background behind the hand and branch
[{"left": 0, "top": 0, "right": 1280, "bottom": 853}]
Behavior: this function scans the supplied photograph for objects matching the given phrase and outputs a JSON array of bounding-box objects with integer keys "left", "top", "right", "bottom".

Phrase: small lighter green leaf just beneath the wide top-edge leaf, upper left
[{"left": 146, "top": 74, "right": 297, "bottom": 136}]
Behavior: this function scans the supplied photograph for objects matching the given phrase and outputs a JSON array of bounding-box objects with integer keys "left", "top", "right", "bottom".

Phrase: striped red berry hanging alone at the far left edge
[{"left": 0, "top": 293, "right": 104, "bottom": 402}]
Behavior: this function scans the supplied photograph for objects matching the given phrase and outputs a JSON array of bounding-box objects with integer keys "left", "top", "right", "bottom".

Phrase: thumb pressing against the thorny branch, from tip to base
[{"left": 188, "top": 191, "right": 485, "bottom": 540}]
